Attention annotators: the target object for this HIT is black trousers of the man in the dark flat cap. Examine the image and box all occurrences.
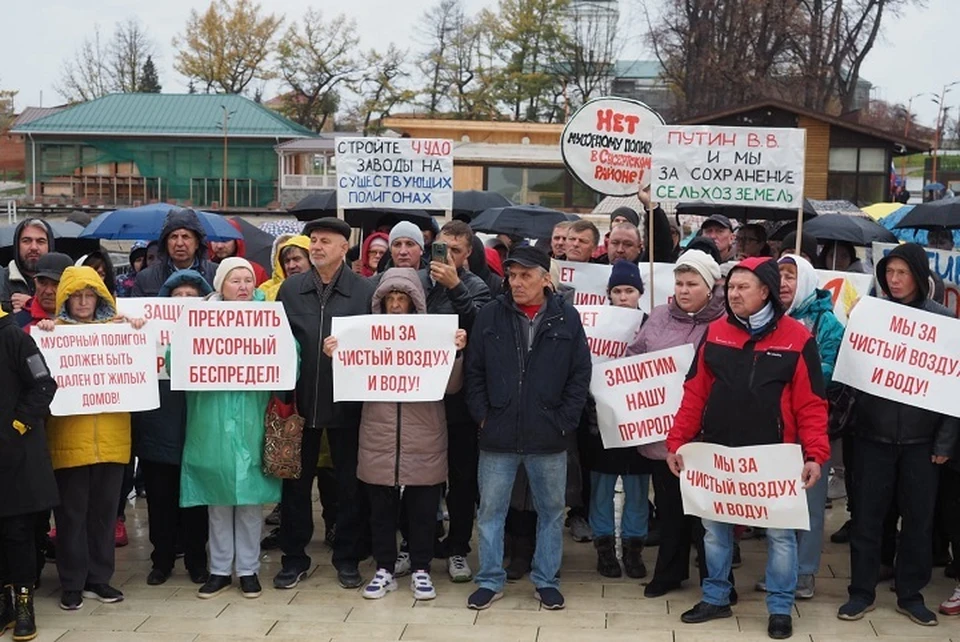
[280,428,370,570]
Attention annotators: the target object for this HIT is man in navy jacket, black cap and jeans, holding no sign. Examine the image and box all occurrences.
[466,247,591,610]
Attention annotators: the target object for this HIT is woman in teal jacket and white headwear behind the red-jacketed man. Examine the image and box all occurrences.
[757,254,843,600]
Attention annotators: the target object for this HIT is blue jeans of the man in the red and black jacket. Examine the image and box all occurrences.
[702,519,797,615]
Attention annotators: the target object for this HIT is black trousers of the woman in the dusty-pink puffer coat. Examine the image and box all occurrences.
[370,484,442,572]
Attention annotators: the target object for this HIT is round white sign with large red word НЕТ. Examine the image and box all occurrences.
[560,98,663,196]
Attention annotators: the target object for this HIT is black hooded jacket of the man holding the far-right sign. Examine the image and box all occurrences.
[854,243,960,457]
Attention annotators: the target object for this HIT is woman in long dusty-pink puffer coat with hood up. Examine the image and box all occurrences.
[323,268,467,600]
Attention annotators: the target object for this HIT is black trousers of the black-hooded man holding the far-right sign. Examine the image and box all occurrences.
[848,438,940,606]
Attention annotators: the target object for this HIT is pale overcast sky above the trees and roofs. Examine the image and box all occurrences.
[0,0,960,125]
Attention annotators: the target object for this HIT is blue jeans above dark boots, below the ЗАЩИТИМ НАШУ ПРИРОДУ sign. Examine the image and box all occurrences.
[590,471,650,538]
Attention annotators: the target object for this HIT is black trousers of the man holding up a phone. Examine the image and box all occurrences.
[444,423,480,555]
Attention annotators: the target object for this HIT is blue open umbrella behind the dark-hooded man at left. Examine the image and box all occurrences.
[80,203,241,241]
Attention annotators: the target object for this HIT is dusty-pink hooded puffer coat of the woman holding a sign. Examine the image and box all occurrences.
[357,268,463,486]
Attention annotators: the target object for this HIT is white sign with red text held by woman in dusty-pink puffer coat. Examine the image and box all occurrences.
[330,314,457,401]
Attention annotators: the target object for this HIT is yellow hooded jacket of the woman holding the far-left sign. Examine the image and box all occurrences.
[47,267,131,470]
